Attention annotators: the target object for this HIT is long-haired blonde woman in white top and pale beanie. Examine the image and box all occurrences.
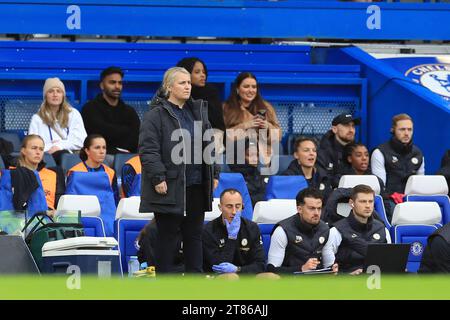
[28,78,87,165]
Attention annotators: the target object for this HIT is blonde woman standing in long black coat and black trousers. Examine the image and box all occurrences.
[139,67,218,273]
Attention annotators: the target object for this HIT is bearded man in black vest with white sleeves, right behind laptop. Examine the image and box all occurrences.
[322,184,391,274]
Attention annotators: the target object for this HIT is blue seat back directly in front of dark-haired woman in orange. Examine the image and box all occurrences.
[66,172,116,237]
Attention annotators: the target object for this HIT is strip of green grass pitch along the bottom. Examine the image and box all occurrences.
[0,275,450,300]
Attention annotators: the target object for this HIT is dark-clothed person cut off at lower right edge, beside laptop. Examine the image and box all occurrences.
[419,223,450,273]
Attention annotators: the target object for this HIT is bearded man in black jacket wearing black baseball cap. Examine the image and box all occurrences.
[317,113,361,187]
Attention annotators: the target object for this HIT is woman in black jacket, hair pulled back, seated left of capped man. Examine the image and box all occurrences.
[283,137,332,203]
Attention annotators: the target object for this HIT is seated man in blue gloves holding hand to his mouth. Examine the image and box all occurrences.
[202,188,265,274]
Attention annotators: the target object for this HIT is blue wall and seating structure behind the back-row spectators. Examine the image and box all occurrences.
[0,41,367,151]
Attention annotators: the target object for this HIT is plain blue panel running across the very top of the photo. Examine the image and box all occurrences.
[0,0,450,40]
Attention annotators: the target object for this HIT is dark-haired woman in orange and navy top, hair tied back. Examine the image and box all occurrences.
[67,134,120,205]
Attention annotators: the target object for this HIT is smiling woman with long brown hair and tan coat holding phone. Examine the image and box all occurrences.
[223,72,281,164]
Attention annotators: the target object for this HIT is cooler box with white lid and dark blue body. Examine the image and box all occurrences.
[42,237,122,276]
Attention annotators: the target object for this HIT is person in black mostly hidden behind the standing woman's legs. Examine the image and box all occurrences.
[136,219,184,272]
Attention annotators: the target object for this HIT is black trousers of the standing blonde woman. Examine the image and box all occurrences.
[155,185,205,273]
